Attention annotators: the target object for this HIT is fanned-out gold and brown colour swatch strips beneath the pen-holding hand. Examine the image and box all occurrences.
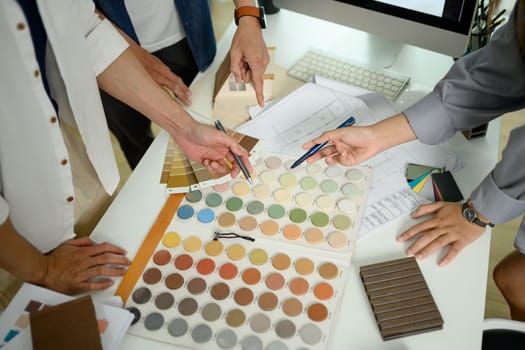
[160,129,259,193]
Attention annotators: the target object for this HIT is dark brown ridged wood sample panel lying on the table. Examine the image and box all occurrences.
[359,257,443,340]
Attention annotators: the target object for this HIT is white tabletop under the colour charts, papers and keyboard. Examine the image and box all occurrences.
[92,10,499,350]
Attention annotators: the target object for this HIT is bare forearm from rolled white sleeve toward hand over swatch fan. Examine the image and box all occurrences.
[97,49,195,135]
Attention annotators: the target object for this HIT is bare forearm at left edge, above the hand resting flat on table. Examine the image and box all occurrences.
[0,219,47,284]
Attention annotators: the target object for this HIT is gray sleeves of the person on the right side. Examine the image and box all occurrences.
[404,9,525,226]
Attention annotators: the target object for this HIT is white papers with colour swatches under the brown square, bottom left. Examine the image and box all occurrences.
[0,283,133,350]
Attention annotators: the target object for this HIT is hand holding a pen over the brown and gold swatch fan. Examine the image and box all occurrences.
[173,123,252,177]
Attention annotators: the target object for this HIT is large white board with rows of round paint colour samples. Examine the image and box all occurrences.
[126,153,372,350]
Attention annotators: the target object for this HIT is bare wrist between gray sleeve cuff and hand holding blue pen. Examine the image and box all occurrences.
[371,113,416,151]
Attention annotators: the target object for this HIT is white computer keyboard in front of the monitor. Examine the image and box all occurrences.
[287,51,410,100]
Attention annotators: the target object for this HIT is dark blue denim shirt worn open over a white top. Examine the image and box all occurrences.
[95,0,217,71]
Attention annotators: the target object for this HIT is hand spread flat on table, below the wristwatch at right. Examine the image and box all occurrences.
[397,202,485,266]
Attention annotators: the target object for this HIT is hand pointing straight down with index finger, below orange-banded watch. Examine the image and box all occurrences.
[230,16,270,107]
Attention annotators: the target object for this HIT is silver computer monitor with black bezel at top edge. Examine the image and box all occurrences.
[274,0,478,61]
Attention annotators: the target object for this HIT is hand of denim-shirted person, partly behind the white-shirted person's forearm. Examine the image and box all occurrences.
[131,45,191,106]
